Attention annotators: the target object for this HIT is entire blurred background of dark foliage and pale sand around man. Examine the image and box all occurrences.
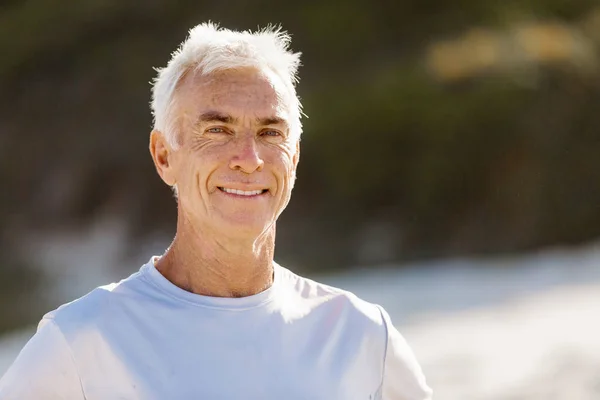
[0,0,600,400]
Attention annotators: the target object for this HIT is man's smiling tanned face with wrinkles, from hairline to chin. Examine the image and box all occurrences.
[152,69,299,236]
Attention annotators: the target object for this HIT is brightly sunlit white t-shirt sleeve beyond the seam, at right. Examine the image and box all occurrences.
[379,307,432,400]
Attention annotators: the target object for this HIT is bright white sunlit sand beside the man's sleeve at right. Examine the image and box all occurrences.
[402,285,600,400]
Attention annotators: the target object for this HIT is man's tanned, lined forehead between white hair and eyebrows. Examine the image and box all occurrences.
[177,68,289,120]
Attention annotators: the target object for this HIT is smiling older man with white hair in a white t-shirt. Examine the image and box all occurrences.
[0,24,431,400]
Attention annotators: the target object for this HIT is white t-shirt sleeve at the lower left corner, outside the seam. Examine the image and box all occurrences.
[0,318,85,400]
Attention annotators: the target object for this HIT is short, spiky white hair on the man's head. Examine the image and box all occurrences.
[151,22,302,147]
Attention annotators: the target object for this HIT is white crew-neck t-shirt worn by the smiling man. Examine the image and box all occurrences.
[0,260,431,400]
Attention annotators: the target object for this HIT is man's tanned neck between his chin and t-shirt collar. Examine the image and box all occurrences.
[156,216,275,297]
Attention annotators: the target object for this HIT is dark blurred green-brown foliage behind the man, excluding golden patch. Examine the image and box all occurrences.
[0,0,600,278]
